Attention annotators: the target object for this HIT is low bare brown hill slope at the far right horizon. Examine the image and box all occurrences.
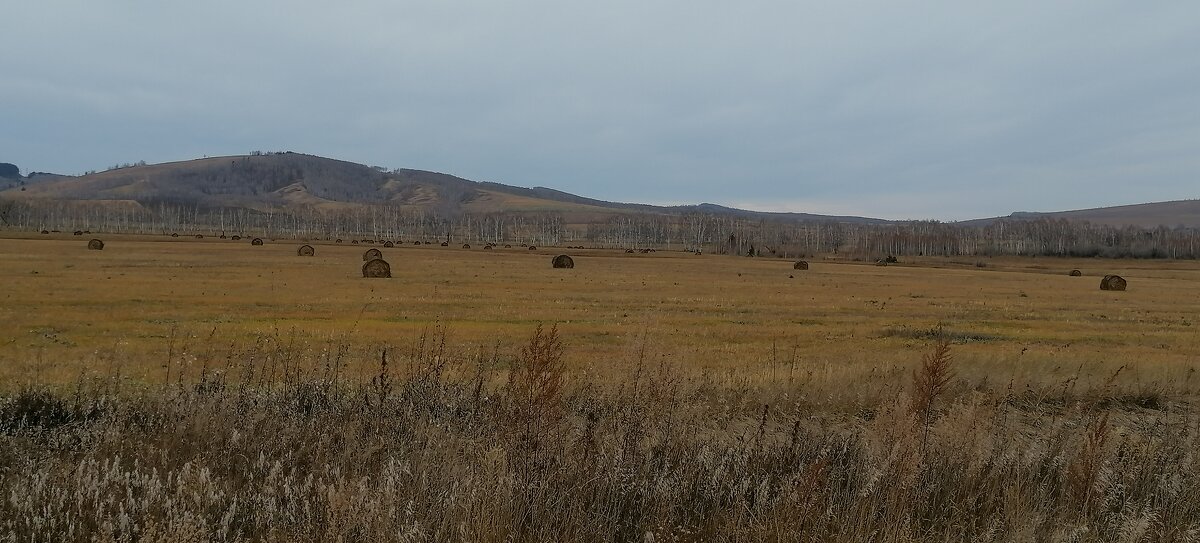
[964,199,1200,228]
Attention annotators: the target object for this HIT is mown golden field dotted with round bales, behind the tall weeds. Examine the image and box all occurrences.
[0,234,1200,391]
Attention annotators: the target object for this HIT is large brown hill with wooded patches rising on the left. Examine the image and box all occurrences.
[0,153,887,223]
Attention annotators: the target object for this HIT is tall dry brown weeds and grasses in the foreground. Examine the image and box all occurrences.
[0,327,1200,542]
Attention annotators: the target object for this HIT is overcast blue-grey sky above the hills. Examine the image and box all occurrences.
[0,0,1200,220]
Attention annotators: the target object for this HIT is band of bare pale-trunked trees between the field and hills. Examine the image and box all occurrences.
[0,199,1200,258]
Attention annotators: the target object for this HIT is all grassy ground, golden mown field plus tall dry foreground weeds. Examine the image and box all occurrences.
[0,234,1200,541]
